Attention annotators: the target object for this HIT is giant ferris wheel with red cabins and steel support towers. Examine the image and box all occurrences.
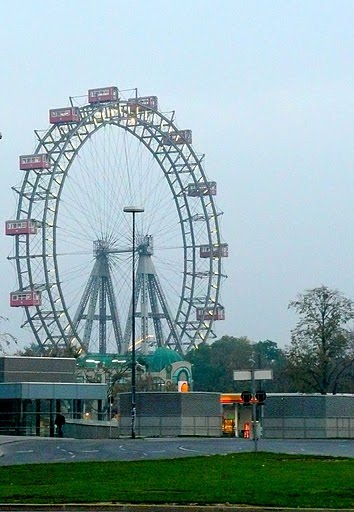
[6,87,228,354]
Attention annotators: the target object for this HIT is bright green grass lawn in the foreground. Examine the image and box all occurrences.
[0,452,354,508]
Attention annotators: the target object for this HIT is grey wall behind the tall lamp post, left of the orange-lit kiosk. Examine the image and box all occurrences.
[119,392,221,437]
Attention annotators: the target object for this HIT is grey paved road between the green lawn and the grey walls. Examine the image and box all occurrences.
[0,436,354,466]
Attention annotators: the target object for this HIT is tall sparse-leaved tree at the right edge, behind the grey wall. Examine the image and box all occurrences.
[286,285,354,394]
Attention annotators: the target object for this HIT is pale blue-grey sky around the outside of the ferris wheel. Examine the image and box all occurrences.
[0,0,354,346]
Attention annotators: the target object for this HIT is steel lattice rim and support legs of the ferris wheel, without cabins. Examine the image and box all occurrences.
[13,90,226,353]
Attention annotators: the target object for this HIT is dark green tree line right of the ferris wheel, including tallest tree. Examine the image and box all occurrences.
[186,286,354,394]
